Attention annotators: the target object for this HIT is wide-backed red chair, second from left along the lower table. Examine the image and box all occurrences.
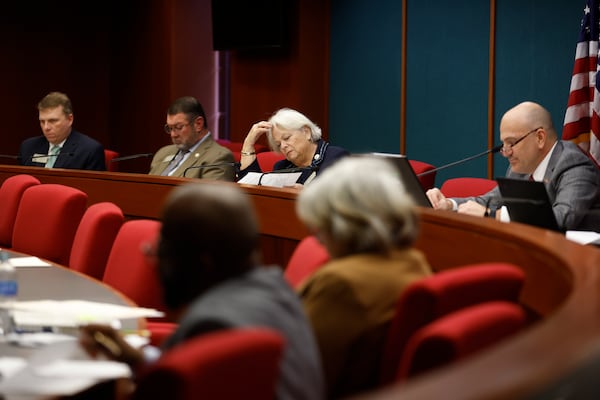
[12,183,88,265]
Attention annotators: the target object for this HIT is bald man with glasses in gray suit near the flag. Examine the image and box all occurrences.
[427,101,600,231]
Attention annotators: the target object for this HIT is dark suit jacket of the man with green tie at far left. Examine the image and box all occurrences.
[19,130,106,171]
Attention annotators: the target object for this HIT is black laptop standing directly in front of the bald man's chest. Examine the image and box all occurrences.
[496,178,561,232]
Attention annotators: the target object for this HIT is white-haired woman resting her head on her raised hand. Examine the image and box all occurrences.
[238,108,349,184]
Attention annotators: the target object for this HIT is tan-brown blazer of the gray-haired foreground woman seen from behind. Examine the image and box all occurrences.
[298,249,432,398]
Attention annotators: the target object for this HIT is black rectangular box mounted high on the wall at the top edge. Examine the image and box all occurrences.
[211,0,294,50]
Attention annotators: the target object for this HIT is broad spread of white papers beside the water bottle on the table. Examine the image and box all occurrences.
[13,300,164,328]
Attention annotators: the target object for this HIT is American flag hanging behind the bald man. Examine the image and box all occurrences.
[562,0,600,163]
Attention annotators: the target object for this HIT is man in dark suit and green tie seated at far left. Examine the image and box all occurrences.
[19,92,106,171]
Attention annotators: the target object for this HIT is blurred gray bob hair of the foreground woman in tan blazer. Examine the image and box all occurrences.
[297,157,417,256]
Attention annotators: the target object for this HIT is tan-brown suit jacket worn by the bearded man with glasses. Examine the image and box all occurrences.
[149,134,236,182]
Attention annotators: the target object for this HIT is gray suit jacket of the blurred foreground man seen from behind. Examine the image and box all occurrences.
[163,267,325,400]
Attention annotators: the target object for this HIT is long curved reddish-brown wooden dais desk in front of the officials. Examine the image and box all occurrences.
[0,166,600,400]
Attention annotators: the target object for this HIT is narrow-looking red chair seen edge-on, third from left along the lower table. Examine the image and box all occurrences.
[69,202,125,280]
